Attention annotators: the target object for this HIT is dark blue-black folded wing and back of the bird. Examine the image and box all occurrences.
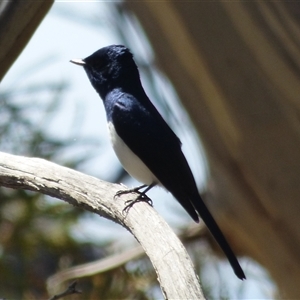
[111,95,199,221]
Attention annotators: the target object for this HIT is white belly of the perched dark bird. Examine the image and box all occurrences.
[108,122,159,185]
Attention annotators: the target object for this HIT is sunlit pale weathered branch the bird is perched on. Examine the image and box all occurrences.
[0,153,204,299]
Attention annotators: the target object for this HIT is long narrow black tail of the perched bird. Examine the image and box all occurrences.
[193,195,246,280]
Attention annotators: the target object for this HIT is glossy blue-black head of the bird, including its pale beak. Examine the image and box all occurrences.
[71,45,139,99]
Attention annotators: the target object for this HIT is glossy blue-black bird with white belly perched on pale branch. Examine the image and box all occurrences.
[70,45,246,280]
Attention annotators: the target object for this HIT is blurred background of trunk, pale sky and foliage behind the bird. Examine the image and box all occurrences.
[0,1,300,299]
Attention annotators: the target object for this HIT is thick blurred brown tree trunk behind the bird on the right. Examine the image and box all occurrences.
[126,1,300,298]
